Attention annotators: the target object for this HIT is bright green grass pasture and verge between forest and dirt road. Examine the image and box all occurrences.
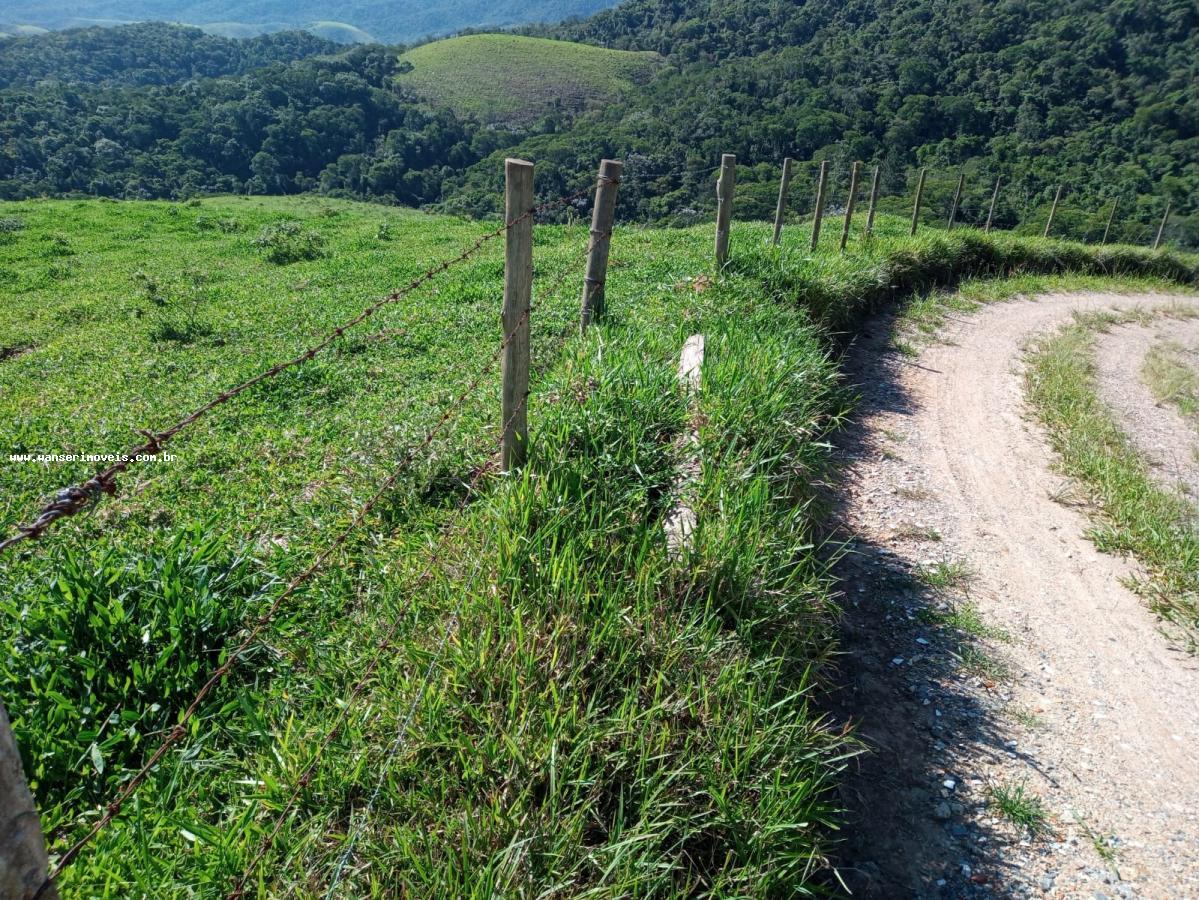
[0,198,1199,896]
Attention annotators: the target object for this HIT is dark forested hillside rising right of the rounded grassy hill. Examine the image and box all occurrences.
[484,0,1199,236]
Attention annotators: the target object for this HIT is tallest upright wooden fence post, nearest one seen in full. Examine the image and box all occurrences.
[500,159,534,472]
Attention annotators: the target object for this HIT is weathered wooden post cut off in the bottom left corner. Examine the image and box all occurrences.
[0,701,59,900]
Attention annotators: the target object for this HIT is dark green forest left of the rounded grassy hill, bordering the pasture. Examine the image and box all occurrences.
[0,47,512,205]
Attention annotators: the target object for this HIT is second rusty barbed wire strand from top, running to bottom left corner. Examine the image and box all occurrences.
[35,210,613,900]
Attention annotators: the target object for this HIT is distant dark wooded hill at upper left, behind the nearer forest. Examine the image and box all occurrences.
[0,22,343,87]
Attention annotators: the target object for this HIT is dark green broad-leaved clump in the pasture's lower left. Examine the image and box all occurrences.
[0,526,259,803]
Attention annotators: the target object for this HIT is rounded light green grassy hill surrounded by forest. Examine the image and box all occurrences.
[399,35,661,125]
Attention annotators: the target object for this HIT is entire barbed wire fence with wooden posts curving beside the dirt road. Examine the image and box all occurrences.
[0,146,1184,898]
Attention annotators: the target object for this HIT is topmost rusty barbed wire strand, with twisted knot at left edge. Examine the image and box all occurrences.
[0,187,591,554]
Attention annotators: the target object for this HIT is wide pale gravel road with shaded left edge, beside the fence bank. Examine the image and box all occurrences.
[832,295,1199,900]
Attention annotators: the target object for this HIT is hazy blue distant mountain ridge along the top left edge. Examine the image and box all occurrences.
[0,0,613,43]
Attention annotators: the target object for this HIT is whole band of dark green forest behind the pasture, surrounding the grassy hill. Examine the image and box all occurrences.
[0,0,1199,246]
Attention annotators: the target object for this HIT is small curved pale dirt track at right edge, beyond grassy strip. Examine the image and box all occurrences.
[1096,319,1199,497]
